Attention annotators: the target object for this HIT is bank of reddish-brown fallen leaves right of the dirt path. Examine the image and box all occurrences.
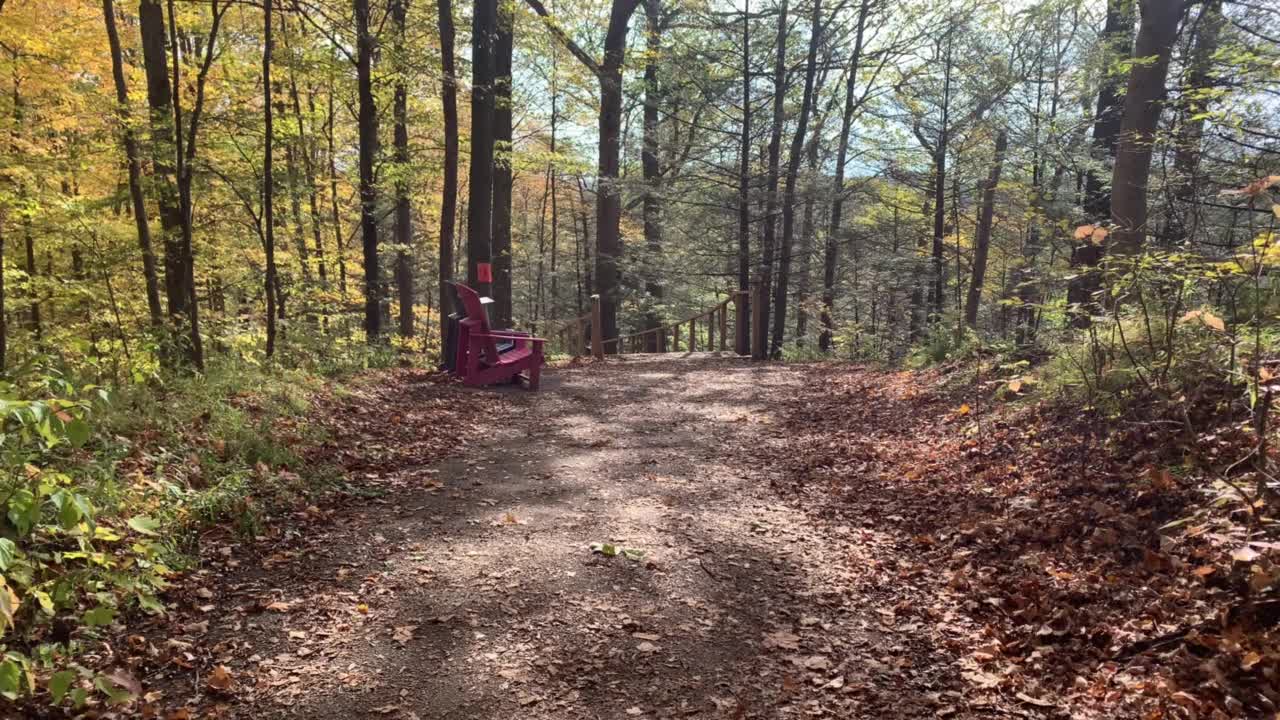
[762,368,1280,719]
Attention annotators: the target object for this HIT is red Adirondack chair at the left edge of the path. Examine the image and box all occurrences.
[453,283,545,389]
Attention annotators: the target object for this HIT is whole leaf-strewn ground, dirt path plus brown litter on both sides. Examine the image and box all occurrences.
[24,355,1277,720]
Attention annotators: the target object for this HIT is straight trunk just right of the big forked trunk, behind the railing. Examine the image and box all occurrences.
[640,0,663,352]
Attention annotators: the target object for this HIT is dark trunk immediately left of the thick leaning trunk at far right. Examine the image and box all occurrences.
[1066,0,1137,327]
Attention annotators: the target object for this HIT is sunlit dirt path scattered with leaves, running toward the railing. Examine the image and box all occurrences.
[164,356,955,719]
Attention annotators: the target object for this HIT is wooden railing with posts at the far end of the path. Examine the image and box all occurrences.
[547,288,759,357]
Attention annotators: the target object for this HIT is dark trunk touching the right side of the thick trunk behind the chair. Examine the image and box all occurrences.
[493,0,516,328]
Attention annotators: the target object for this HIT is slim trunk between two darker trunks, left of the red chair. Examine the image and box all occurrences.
[392,0,413,337]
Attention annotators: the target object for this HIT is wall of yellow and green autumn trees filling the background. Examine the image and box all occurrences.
[0,0,1280,366]
